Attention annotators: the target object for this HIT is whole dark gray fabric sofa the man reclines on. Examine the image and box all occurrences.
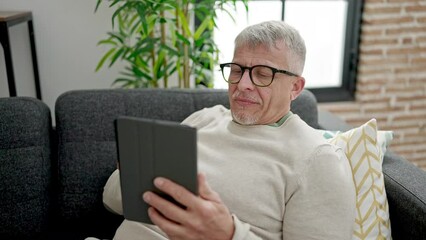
[0,89,426,239]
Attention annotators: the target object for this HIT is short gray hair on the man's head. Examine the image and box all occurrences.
[235,21,306,75]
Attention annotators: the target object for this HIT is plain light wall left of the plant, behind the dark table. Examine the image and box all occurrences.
[0,0,125,119]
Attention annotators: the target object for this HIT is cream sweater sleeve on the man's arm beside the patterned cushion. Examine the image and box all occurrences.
[283,145,356,240]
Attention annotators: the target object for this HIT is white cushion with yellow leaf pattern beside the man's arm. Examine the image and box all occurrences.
[324,119,392,239]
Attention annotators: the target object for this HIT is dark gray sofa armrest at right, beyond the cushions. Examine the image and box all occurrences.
[383,151,426,240]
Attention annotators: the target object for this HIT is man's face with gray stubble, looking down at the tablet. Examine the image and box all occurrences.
[228,43,304,125]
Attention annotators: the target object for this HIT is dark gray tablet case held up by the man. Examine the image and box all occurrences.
[115,117,198,224]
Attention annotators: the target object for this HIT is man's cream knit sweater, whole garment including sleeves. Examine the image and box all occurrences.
[104,106,355,240]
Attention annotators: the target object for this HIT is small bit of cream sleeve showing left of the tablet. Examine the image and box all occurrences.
[102,169,123,215]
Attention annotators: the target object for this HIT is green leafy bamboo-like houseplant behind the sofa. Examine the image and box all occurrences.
[95,0,248,88]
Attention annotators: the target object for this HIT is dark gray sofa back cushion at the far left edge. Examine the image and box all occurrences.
[0,97,52,239]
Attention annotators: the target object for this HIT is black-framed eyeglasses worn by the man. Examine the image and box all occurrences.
[219,63,299,87]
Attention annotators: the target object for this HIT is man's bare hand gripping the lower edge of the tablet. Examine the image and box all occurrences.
[143,174,234,240]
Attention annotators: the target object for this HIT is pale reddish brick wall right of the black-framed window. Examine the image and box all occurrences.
[320,0,426,170]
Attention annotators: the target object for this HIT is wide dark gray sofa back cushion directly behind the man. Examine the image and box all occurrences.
[55,89,318,238]
